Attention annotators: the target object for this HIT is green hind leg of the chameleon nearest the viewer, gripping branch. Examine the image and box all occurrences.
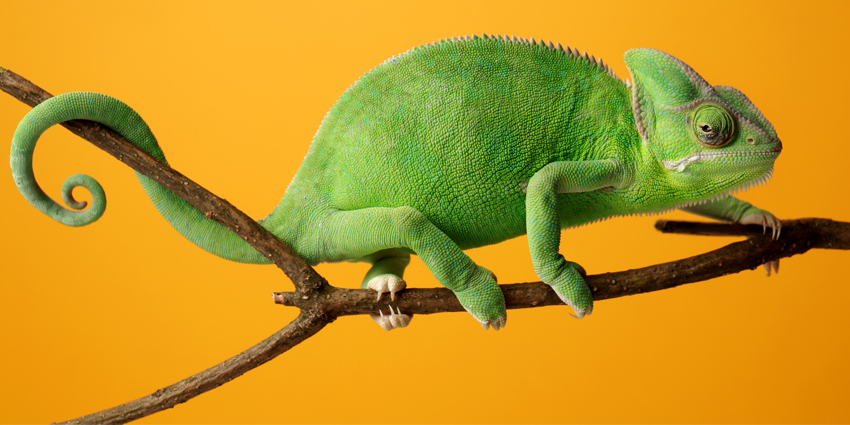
[311,207,506,330]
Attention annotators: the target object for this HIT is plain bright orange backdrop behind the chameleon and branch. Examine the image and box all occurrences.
[0,0,850,423]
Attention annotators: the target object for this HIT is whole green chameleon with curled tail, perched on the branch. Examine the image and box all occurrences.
[11,35,782,330]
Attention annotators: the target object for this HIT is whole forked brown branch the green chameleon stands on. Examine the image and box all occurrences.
[0,68,850,424]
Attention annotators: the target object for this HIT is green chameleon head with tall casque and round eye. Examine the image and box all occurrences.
[625,49,782,201]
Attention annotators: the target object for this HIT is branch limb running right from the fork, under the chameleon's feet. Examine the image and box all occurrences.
[274,218,850,317]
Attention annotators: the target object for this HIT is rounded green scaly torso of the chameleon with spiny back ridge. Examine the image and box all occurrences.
[282,37,638,249]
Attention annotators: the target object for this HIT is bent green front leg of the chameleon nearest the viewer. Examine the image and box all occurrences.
[525,160,622,318]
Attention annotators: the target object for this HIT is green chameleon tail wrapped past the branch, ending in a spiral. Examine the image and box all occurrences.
[11,92,269,264]
